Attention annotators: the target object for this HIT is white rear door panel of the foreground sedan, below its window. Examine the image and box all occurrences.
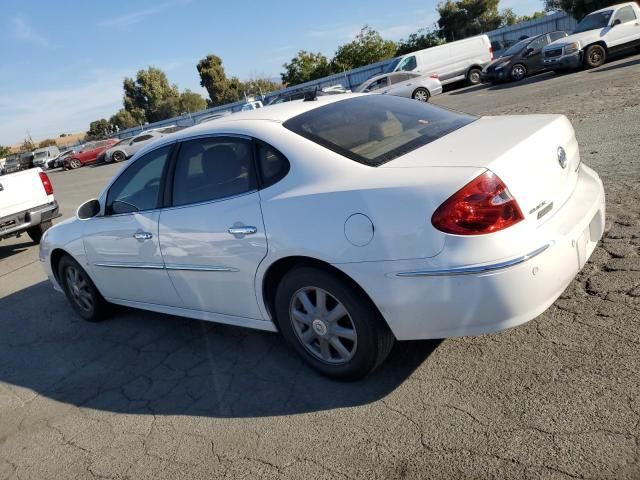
[159,192,267,319]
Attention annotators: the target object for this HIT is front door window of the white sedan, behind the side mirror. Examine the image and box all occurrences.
[105,145,171,215]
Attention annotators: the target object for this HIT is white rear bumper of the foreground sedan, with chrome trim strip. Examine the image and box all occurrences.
[336,166,605,340]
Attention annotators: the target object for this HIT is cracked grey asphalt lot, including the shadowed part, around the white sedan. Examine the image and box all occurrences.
[0,50,640,480]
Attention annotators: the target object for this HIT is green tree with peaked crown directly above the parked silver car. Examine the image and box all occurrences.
[331,25,397,72]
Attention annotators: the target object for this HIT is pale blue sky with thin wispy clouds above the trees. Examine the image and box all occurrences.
[0,0,543,145]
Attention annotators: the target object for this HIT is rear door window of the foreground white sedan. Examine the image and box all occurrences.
[172,137,257,206]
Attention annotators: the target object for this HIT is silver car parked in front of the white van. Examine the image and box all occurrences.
[356,72,442,102]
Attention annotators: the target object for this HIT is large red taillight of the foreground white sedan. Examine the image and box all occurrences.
[431,171,524,235]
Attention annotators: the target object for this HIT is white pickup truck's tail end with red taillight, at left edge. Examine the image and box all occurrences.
[0,168,60,243]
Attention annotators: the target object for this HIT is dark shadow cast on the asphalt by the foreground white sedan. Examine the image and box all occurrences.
[0,282,440,417]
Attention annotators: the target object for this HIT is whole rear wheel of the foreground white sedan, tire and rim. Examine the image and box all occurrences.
[275,267,395,380]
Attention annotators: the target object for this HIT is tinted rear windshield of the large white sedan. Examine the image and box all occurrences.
[284,94,476,167]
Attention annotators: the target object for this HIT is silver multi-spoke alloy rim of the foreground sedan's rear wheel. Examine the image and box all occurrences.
[289,287,358,365]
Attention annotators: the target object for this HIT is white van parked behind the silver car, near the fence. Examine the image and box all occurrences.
[385,35,493,85]
